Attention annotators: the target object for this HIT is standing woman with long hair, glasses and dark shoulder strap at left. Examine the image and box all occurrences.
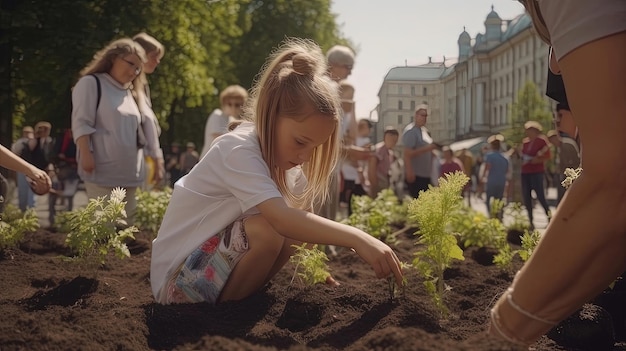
[72,38,147,224]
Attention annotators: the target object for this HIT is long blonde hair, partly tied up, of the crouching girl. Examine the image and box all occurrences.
[244,38,340,209]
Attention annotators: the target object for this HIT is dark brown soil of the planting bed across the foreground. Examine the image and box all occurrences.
[0,230,626,351]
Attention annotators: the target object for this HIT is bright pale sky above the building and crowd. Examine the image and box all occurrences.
[332,0,524,118]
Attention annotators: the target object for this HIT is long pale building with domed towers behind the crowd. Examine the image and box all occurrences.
[376,6,552,148]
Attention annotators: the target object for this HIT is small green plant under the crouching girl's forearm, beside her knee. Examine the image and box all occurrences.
[289,243,330,286]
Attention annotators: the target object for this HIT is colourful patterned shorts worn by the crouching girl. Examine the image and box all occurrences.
[166,218,248,304]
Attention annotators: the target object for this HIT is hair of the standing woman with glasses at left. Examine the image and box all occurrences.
[80,38,148,103]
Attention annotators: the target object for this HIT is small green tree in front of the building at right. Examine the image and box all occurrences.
[503,81,553,145]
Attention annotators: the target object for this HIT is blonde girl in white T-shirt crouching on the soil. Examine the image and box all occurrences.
[150,39,402,304]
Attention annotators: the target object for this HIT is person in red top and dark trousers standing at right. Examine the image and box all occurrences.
[522,121,551,228]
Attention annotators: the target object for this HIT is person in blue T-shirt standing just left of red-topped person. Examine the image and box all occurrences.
[483,134,511,218]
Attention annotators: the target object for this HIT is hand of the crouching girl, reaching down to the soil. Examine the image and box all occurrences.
[354,234,402,286]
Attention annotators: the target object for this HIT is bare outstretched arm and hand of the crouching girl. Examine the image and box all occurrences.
[257,198,402,285]
